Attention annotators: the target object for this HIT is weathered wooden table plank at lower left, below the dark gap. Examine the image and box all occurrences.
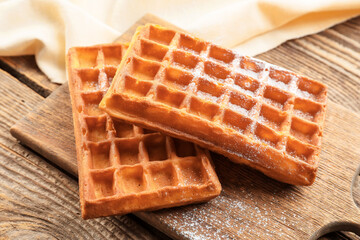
[0,70,163,239]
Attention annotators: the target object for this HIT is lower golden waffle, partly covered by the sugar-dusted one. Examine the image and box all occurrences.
[67,44,221,219]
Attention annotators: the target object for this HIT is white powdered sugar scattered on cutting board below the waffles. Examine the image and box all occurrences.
[155,187,306,240]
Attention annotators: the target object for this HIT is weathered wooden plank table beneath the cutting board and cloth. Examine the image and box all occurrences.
[0,13,360,239]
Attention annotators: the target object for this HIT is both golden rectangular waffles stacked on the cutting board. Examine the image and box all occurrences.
[67,24,327,218]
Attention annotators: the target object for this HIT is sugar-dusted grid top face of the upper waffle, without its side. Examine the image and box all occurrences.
[102,25,326,186]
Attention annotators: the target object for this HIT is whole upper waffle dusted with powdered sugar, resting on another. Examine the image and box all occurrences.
[100,25,327,185]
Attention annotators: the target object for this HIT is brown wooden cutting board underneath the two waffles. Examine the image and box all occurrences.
[11,15,360,239]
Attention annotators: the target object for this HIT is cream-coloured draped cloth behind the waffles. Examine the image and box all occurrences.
[0,0,360,83]
